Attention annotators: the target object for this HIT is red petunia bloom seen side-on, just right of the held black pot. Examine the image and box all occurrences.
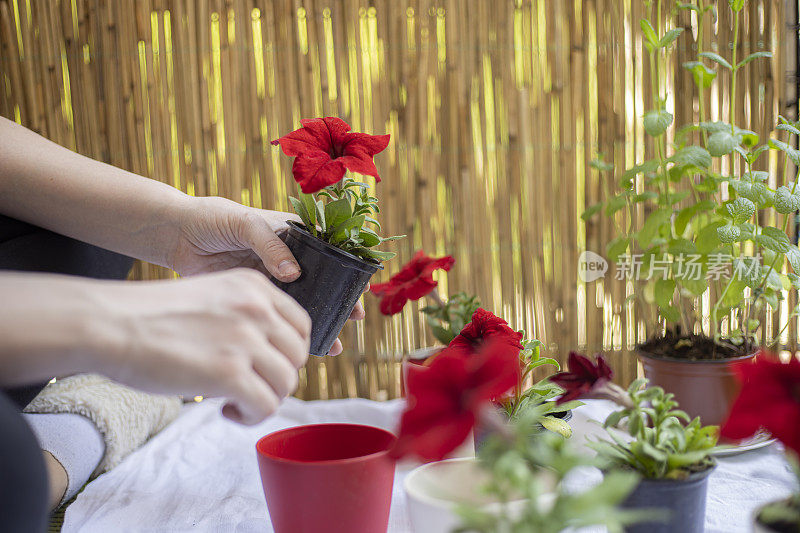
[370,250,456,315]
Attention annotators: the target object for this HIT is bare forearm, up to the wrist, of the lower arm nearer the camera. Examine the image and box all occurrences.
[0,273,119,386]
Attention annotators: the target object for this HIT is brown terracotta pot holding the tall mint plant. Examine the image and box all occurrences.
[637,350,756,426]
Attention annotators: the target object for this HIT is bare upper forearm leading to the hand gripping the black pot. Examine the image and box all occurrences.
[0,117,190,266]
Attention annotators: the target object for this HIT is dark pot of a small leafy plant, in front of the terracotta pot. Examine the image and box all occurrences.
[622,465,716,533]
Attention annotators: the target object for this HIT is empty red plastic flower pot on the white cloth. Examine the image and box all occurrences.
[256,424,397,533]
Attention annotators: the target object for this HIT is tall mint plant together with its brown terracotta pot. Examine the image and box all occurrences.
[583,0,800,424]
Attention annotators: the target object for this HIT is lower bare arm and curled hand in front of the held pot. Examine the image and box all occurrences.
[0,269,311,424]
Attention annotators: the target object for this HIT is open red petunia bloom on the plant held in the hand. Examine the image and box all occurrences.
[272,117,389,194]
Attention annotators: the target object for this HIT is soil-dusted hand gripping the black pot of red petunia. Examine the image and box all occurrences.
[172,197,364,355]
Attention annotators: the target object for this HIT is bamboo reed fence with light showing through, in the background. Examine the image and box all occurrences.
[0,0,797,399]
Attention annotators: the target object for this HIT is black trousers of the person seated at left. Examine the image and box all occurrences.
[0,215,133,533]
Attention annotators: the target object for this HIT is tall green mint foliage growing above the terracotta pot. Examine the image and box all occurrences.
[582,0,800,339]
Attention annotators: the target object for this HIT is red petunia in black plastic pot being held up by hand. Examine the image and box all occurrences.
[272,117,403,356]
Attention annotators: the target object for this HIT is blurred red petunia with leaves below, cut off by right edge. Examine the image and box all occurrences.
[720,354,800,533]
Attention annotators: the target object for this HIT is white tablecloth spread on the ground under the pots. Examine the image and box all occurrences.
[63,399,795,533]
